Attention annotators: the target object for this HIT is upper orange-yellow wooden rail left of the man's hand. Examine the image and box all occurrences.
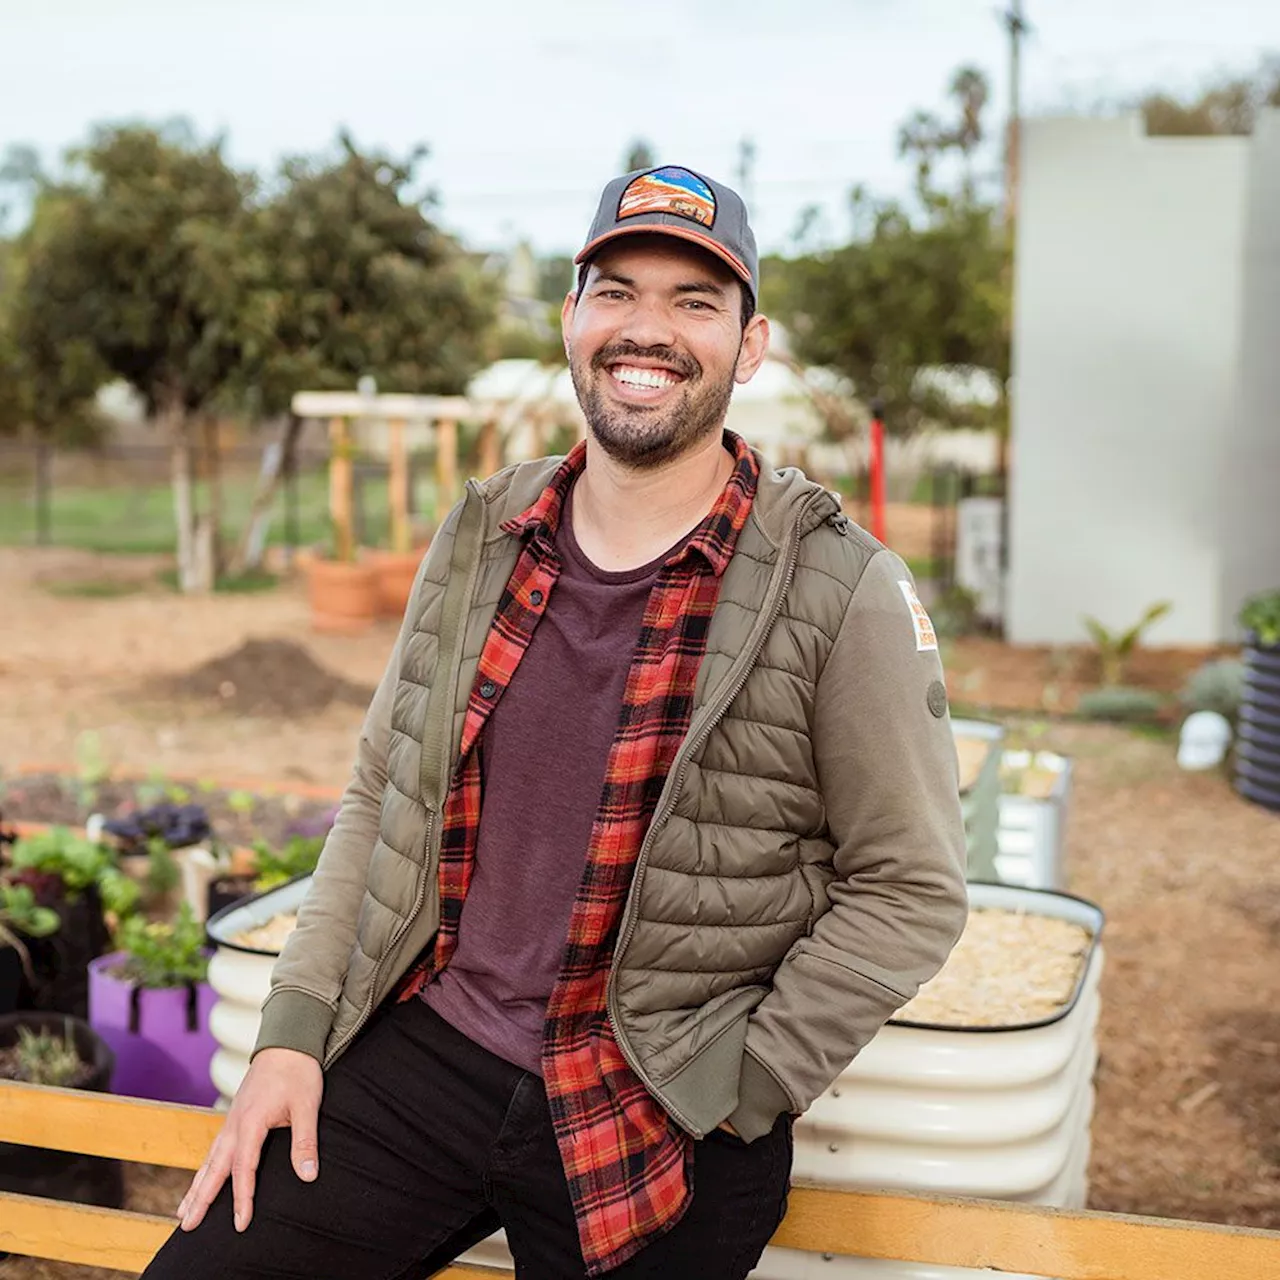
[0,1080,223,1169]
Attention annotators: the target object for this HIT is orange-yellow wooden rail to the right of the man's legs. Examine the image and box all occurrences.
[773,1187,1280,1280]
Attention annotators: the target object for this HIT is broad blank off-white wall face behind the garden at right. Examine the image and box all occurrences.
[1006,118,1249,644]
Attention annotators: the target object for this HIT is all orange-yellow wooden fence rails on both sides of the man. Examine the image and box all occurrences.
[0,1083,1280,1280]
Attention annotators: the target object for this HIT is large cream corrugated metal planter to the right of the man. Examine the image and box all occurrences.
[754,884,1102,1280]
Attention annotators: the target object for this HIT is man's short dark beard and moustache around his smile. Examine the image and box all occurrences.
[568,343,733,471]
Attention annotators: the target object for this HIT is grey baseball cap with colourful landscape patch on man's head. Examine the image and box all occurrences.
[573,165,760,303]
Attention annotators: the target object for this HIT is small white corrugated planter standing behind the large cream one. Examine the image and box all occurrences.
[996,751,1071,888]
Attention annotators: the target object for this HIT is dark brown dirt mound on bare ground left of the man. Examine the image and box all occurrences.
[164,639,374,716]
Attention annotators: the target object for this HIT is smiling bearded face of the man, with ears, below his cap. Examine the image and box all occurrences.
[562,234,769,470]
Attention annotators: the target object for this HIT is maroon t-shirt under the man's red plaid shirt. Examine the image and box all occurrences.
[422,493,686,1075]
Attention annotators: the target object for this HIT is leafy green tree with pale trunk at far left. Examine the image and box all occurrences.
[10,125,258,590]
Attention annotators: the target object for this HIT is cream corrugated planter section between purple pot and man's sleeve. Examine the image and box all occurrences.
[206,876,311,1106]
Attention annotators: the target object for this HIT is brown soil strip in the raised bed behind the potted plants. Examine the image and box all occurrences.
[4,773,334,845]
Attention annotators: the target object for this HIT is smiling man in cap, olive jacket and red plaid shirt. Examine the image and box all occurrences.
[147,166,965,1280]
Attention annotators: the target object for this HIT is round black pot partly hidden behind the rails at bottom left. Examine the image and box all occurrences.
[0,1012,124,1208]
